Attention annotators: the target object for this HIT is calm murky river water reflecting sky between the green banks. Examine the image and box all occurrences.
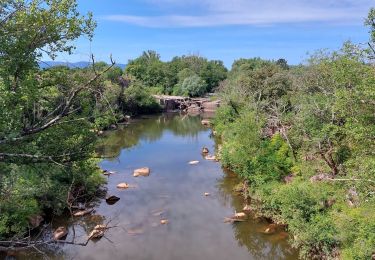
[9,114,298,260]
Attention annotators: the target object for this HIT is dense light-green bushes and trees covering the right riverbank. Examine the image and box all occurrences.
[214,13,375,259]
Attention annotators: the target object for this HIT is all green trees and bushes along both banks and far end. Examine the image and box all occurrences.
[0,0,375,259]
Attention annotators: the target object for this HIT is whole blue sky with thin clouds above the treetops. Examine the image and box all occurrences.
[58,0,375,67]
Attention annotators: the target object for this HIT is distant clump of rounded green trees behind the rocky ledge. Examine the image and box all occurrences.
[125,51,227,97]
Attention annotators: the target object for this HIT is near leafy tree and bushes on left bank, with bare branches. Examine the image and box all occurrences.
[0,0,113,239]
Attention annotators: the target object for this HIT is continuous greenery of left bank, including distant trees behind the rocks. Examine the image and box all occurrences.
[0,0,227,244]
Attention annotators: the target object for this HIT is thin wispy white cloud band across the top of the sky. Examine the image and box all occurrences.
[104,0,375,27]
